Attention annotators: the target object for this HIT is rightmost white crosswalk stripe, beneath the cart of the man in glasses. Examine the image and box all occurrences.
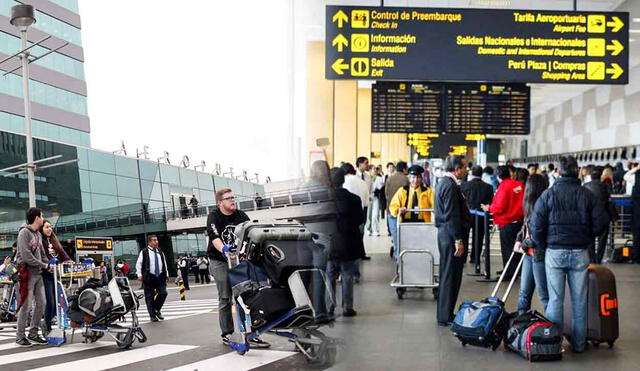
[165,350,296,371]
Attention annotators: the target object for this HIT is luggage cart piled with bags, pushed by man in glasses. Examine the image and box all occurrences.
[227,220,340,366]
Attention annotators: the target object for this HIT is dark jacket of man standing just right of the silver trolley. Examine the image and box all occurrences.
[436,176,471,240]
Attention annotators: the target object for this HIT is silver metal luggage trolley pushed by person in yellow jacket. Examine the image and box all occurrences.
[391,209,440,300]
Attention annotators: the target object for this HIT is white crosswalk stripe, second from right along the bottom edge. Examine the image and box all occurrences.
[27,344,197,371]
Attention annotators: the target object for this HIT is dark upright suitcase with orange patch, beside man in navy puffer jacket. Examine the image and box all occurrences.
[563,265,619,347]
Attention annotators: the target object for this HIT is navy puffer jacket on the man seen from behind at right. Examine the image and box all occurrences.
[529,178,609,249]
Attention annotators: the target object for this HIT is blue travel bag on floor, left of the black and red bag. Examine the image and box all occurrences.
[451,297,506,350]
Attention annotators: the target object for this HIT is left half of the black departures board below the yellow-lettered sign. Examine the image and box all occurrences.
[371,82,443,133]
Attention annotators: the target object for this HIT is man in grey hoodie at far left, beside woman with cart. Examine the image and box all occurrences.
[16,207,55,347]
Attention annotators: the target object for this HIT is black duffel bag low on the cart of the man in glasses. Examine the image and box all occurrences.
[245,287,296,329]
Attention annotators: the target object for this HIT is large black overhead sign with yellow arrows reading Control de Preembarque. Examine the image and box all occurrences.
[325,6,629,84]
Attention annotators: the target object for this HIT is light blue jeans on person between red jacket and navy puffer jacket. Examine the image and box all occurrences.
[518,254,549,311]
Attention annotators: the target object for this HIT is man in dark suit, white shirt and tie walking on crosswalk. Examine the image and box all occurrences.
[136,234,168,322]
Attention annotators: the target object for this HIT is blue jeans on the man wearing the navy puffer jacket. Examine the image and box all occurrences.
[545,249,589,352]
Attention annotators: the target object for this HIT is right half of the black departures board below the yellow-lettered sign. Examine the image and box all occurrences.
[445,84,531,135]
